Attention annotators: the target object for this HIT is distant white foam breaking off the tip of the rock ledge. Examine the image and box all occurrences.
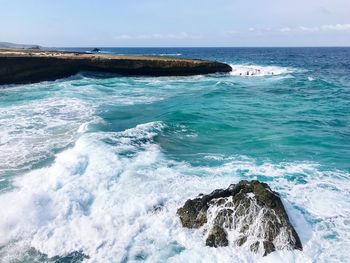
[230,64,292,77]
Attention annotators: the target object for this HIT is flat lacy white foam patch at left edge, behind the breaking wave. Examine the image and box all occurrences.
[0,98,93,170]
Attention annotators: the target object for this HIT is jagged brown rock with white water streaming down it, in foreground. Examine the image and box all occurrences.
[177,180,302,255]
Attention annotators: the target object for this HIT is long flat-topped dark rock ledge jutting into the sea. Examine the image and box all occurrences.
[0,49,232,85]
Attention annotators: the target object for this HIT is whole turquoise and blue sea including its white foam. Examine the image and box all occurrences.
[0,48,350,262]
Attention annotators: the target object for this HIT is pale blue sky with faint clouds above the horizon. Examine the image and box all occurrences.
[0,0,350,47]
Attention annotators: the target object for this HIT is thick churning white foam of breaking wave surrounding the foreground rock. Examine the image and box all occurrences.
[0,122,350,262]
